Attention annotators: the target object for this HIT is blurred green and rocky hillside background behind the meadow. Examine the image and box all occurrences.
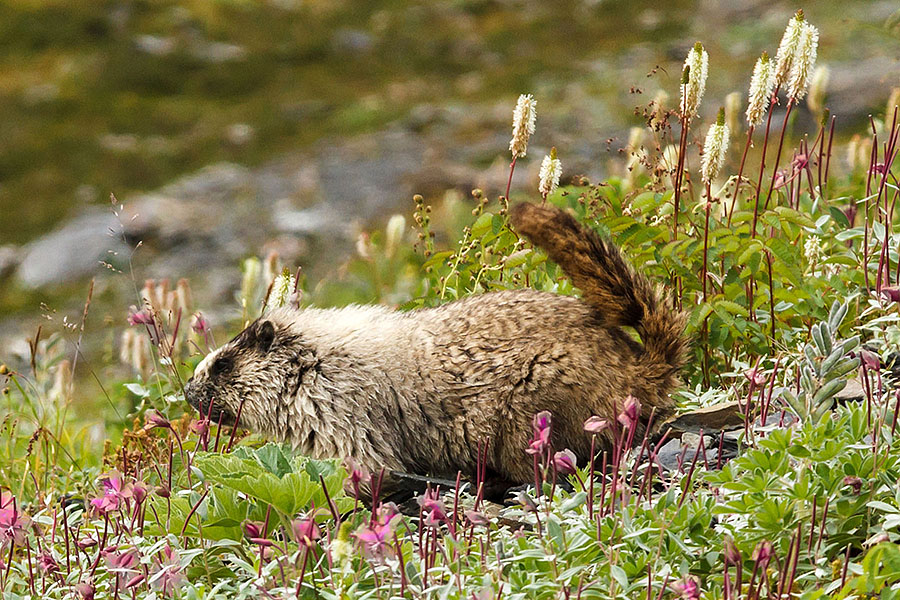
[0,0,900,372]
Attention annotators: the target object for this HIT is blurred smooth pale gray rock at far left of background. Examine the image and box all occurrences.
[16,213,128,289]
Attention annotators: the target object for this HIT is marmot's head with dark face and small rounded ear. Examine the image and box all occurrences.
[184,316,316,432]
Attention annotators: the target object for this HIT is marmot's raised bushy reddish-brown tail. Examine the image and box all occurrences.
[510,203,686,374]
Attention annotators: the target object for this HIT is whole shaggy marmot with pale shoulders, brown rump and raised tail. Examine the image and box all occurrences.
[185,204,686,483]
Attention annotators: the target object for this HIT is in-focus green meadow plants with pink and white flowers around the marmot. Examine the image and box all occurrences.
[0,11,900,600]
